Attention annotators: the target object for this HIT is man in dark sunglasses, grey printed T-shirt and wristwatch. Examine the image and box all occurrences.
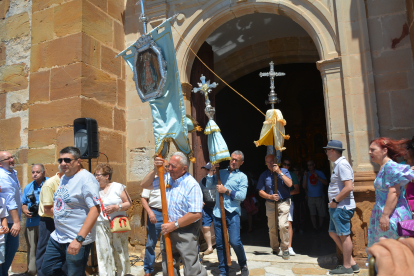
[42,147,100,276]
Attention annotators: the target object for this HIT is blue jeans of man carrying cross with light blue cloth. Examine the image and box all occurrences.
[214,210,247,275]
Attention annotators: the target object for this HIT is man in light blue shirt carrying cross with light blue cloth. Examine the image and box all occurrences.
[207,150,249,276]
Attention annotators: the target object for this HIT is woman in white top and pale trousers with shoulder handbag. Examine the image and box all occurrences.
[95,164,131,276]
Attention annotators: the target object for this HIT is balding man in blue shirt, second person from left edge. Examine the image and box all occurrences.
[22,164,48,275]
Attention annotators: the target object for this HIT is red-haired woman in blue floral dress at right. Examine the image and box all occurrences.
[367,137,414,247]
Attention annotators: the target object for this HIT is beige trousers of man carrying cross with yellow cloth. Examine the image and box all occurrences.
[266,199,290,252]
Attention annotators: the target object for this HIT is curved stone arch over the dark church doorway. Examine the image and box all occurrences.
[176,0,339,83]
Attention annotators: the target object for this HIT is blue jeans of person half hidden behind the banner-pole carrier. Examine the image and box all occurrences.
[144,209,163,273]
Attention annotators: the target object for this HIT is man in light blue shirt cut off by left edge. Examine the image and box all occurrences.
[0,151,22,276]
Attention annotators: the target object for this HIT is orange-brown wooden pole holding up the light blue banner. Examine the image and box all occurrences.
[157,154,174,276]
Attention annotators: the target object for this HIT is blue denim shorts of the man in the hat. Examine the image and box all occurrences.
[329,208,355,236]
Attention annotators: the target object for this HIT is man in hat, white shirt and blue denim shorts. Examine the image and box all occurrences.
[324,140,359,275]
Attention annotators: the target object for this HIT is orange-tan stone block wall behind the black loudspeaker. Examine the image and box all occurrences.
[0,0,127,271]
